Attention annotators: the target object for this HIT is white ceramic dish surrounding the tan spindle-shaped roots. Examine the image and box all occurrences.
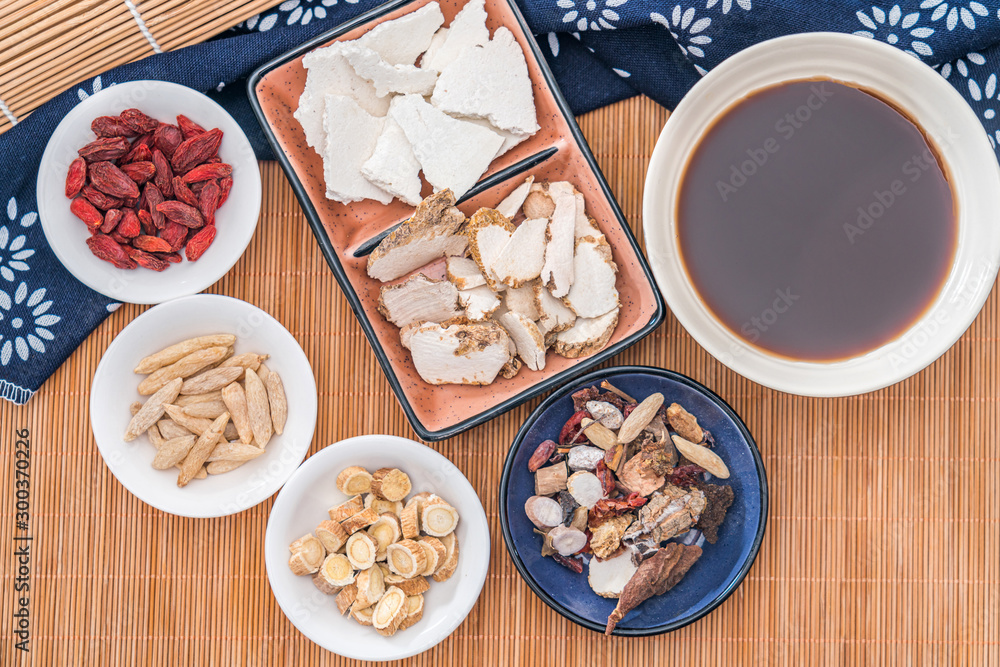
[90,294,316,517]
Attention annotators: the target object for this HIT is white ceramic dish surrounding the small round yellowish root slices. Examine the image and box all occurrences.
[264,435,490,661]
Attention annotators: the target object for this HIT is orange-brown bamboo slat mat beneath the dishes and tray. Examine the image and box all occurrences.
[0,1,1000,667]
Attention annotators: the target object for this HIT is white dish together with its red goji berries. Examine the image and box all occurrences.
[37,81,261,304]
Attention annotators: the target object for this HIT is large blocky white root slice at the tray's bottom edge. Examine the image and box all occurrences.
[400,322,510,385]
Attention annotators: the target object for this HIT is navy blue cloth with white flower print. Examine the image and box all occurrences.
[0,0,1000,403]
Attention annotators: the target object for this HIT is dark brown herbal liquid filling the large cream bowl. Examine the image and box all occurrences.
[677,81,957,361]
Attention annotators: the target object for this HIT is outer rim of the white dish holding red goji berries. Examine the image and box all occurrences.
[35,79,263,305]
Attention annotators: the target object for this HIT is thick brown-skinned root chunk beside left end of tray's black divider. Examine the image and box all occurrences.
[368,189,467,282]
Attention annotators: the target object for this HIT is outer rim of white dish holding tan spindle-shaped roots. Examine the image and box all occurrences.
[88,293,319,519]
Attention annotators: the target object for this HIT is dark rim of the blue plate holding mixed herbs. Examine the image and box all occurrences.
[499,366,770,637]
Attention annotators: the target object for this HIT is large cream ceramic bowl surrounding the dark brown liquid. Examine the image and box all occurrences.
[643,33,1000,396]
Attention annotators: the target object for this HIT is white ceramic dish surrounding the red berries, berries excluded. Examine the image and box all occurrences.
[37,81,261,303]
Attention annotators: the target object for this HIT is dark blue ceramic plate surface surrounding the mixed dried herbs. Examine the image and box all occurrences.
[500,366,768,636]
